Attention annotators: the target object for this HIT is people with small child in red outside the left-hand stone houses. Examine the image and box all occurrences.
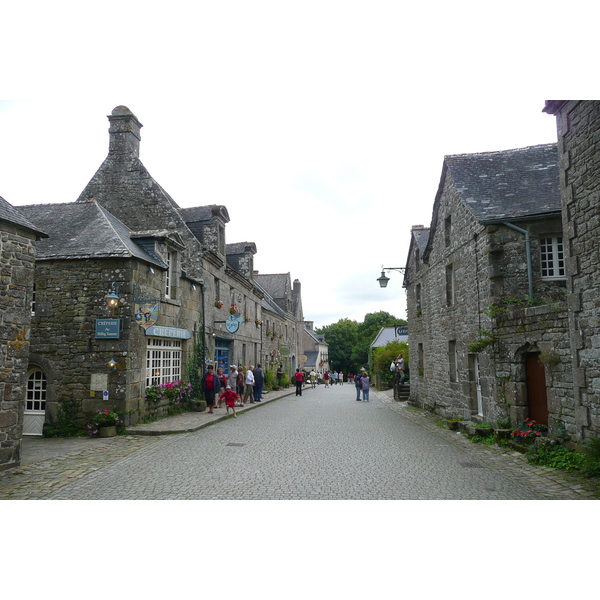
[201,364,265,417]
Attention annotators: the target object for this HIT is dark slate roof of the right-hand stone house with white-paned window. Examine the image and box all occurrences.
[444,144,561,223]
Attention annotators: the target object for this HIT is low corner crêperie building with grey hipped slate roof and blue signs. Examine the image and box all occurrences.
[19,200,202,428]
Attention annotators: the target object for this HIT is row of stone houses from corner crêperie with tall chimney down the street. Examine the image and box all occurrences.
[14,106,310,432]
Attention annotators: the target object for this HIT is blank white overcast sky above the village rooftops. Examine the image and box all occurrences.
[0,0,595,327]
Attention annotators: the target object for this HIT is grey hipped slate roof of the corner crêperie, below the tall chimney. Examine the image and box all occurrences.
[18,201,166,268]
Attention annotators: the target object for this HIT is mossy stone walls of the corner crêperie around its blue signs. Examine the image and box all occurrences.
[30,259,202,424]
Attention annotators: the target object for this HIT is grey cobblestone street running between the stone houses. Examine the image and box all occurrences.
[0,385,598,500]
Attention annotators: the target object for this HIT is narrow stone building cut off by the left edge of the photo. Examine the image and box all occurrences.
[0,197,46,471]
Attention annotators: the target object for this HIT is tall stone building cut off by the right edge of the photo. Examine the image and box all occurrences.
[544,100,600,439]
